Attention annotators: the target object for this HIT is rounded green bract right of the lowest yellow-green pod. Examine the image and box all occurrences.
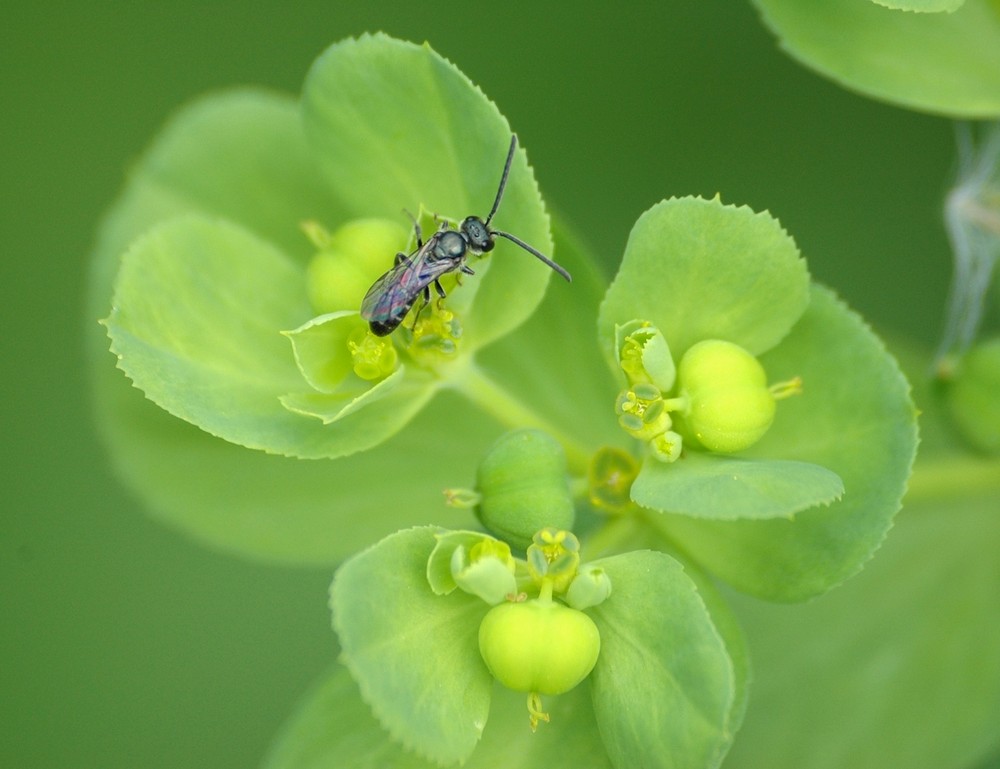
[590,551,735,769]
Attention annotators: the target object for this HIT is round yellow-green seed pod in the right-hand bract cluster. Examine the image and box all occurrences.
[678,339,775,452]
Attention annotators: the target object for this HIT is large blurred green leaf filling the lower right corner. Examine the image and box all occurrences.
[726,472,1000,769]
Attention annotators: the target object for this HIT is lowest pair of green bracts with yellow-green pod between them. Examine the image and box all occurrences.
[328,527,746,769]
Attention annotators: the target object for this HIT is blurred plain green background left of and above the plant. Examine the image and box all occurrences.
[0,0,954,769]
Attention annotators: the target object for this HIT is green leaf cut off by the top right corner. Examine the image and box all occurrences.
[755,0,1000,118]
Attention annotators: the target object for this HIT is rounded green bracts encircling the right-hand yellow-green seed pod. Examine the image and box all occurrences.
[592,198,916,600]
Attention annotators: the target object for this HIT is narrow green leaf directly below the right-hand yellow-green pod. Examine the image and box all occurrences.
[632,451,844,520]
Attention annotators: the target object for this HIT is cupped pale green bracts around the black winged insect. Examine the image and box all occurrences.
[98,36,552,457]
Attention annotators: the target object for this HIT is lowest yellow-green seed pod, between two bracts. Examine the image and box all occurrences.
[479,598,601,694]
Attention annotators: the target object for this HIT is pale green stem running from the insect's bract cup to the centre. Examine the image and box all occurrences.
[449,362,590,475]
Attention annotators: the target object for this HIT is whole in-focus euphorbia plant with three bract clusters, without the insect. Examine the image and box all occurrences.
[94,30,916,767]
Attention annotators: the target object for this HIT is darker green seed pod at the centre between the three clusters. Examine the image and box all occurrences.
[476,430,575,550]
